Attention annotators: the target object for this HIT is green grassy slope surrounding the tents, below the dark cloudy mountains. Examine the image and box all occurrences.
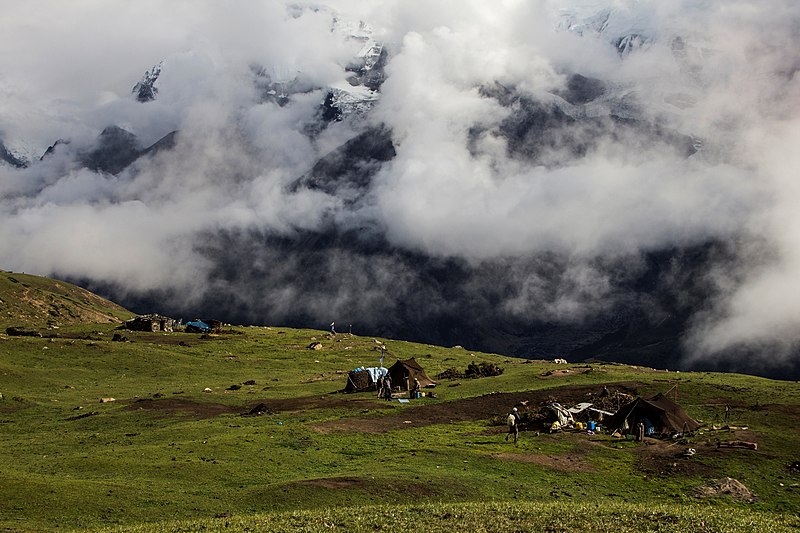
[0,276,800,531]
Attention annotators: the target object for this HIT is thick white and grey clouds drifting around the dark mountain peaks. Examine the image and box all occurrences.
[0,0,800,368]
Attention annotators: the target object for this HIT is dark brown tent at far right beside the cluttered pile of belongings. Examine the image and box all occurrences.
[605,393,700,435]
